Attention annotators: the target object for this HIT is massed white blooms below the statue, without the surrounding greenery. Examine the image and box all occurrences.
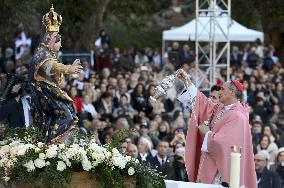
[0,137,139,182]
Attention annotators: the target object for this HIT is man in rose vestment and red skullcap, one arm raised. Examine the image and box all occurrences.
[177,70,257,188]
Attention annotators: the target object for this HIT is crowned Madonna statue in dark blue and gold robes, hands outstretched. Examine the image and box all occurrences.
[29,6,82,143]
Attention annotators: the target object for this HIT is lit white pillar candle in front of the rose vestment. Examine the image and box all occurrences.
[230,145,241,188]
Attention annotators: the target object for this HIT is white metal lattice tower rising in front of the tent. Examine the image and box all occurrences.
[194,0,231,91]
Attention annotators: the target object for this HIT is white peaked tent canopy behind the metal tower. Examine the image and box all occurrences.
[163,15,264,42]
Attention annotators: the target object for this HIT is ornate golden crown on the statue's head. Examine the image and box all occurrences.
[42,5,62,32]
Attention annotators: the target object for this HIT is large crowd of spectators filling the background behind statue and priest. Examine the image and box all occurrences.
[0,30,284,188]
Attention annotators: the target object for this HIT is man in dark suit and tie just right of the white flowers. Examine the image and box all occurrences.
[150,140,174,180]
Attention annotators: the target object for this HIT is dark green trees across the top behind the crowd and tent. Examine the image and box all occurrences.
[0,0,284,59]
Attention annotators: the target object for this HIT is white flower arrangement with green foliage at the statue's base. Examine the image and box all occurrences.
[0,128,165,188]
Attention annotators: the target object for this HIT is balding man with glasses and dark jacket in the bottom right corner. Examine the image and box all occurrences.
[254,150,281,188]
